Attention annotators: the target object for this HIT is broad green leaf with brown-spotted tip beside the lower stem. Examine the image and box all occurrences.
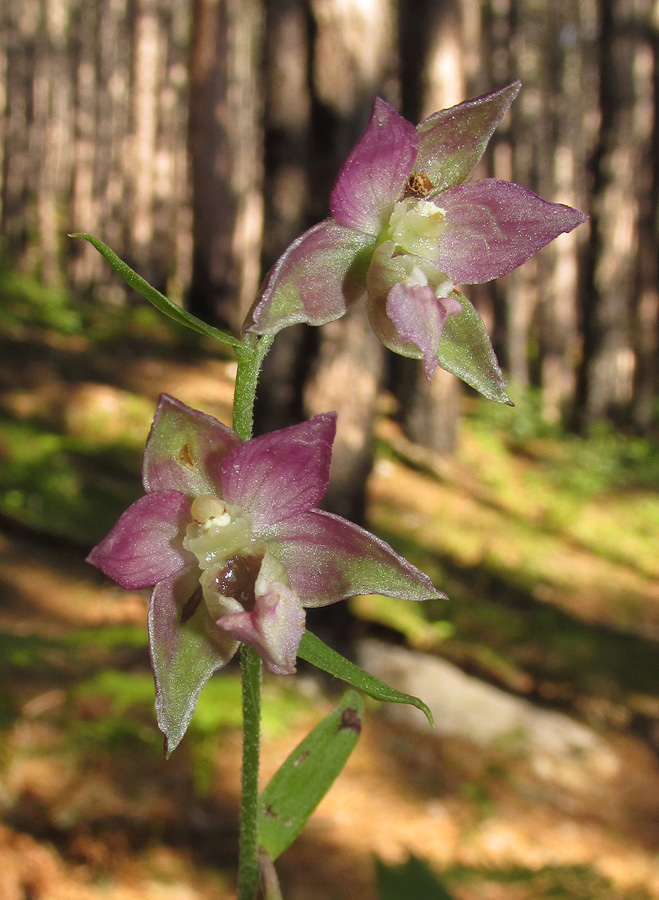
[258,690,364,860]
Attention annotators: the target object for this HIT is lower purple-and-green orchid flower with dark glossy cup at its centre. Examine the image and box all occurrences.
[88,394,443,750]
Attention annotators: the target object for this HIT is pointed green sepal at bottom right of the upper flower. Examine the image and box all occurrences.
[437,291,513,406]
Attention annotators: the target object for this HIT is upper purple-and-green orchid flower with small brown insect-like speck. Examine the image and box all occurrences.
[245,82,587,401]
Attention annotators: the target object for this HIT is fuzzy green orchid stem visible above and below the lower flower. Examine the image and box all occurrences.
[233,335,274,900]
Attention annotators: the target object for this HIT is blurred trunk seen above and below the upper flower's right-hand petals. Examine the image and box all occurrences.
[391,0,466,454]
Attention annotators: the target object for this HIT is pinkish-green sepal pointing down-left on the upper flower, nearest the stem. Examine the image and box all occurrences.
[243,219,375,334]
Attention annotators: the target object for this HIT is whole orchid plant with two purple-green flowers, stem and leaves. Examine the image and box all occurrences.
[72,82,587,900]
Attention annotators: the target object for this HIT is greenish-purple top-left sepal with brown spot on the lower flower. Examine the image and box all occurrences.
[142,394,241,496]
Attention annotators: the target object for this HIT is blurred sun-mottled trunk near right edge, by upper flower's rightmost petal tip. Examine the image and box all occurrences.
[576,0,639,430]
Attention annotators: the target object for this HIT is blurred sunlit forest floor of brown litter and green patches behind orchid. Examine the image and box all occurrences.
[0,276,659,900]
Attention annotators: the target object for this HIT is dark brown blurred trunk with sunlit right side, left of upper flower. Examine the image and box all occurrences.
[189,0,263,330]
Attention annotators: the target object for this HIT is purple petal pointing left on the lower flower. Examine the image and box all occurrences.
[87,491,190,590]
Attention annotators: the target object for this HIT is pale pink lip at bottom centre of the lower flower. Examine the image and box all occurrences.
[217,584,305,675]
